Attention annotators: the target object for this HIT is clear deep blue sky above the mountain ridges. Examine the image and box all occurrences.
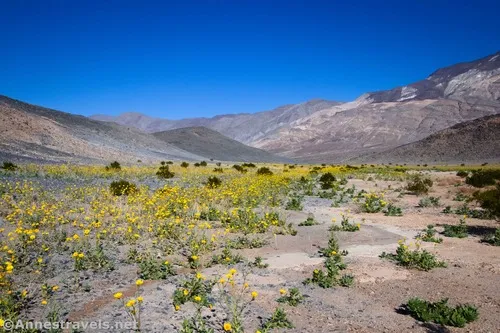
[0,0,500,119]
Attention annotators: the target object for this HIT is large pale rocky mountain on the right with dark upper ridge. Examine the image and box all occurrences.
[251,53,500,162]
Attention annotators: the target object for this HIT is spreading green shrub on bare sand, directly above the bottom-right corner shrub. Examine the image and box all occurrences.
[380,242,446,271]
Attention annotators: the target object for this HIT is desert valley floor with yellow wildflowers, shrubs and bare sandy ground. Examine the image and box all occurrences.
[0,162,500,333]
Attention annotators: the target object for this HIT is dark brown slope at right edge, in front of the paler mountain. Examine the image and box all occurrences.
[351,115,500,163]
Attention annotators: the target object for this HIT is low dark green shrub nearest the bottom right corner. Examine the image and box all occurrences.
[404,298,479,327]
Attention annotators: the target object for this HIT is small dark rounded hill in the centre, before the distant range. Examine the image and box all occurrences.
[153,127,290,162]
